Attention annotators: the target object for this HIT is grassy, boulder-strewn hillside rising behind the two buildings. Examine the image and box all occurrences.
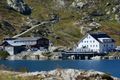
[0,0,120,47]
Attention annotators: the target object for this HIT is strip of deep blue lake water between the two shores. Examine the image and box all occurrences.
[0,60,120,78]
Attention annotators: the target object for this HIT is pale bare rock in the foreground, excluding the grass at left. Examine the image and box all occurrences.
[17,69,118,80]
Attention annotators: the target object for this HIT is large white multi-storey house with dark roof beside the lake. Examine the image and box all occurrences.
[74,32,116,53]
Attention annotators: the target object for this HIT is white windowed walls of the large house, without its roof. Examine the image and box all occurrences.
[76,34,116,53]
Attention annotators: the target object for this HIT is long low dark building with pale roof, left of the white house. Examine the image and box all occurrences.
[2,37,49,55]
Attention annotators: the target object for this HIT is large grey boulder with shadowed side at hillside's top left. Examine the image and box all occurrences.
[7,0,31,15]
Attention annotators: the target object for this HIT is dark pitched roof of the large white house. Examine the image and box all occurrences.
[89,32,115,42]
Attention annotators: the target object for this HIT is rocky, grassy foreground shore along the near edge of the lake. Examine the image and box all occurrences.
[0,69,119,80]
